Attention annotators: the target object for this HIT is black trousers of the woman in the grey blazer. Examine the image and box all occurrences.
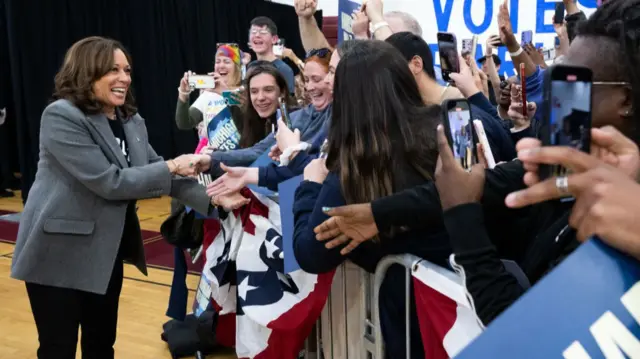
[27,259,123,359]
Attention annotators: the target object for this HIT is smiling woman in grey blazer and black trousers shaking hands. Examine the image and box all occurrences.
[11,37,221,359]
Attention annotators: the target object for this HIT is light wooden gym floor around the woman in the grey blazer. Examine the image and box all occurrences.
[0,192,236,359]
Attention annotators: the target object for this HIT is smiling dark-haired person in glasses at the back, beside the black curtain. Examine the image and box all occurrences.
[249,16,296,94]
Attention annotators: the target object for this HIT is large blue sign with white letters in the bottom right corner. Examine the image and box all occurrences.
[456,239,640,359]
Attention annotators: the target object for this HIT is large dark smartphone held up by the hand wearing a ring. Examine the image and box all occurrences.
[539,65,593,180]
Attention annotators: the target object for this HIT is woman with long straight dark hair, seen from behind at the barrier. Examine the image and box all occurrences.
[294,41,451,357]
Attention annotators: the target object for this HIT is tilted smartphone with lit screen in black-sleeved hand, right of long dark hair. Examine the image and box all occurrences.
[442,99,478,170]
